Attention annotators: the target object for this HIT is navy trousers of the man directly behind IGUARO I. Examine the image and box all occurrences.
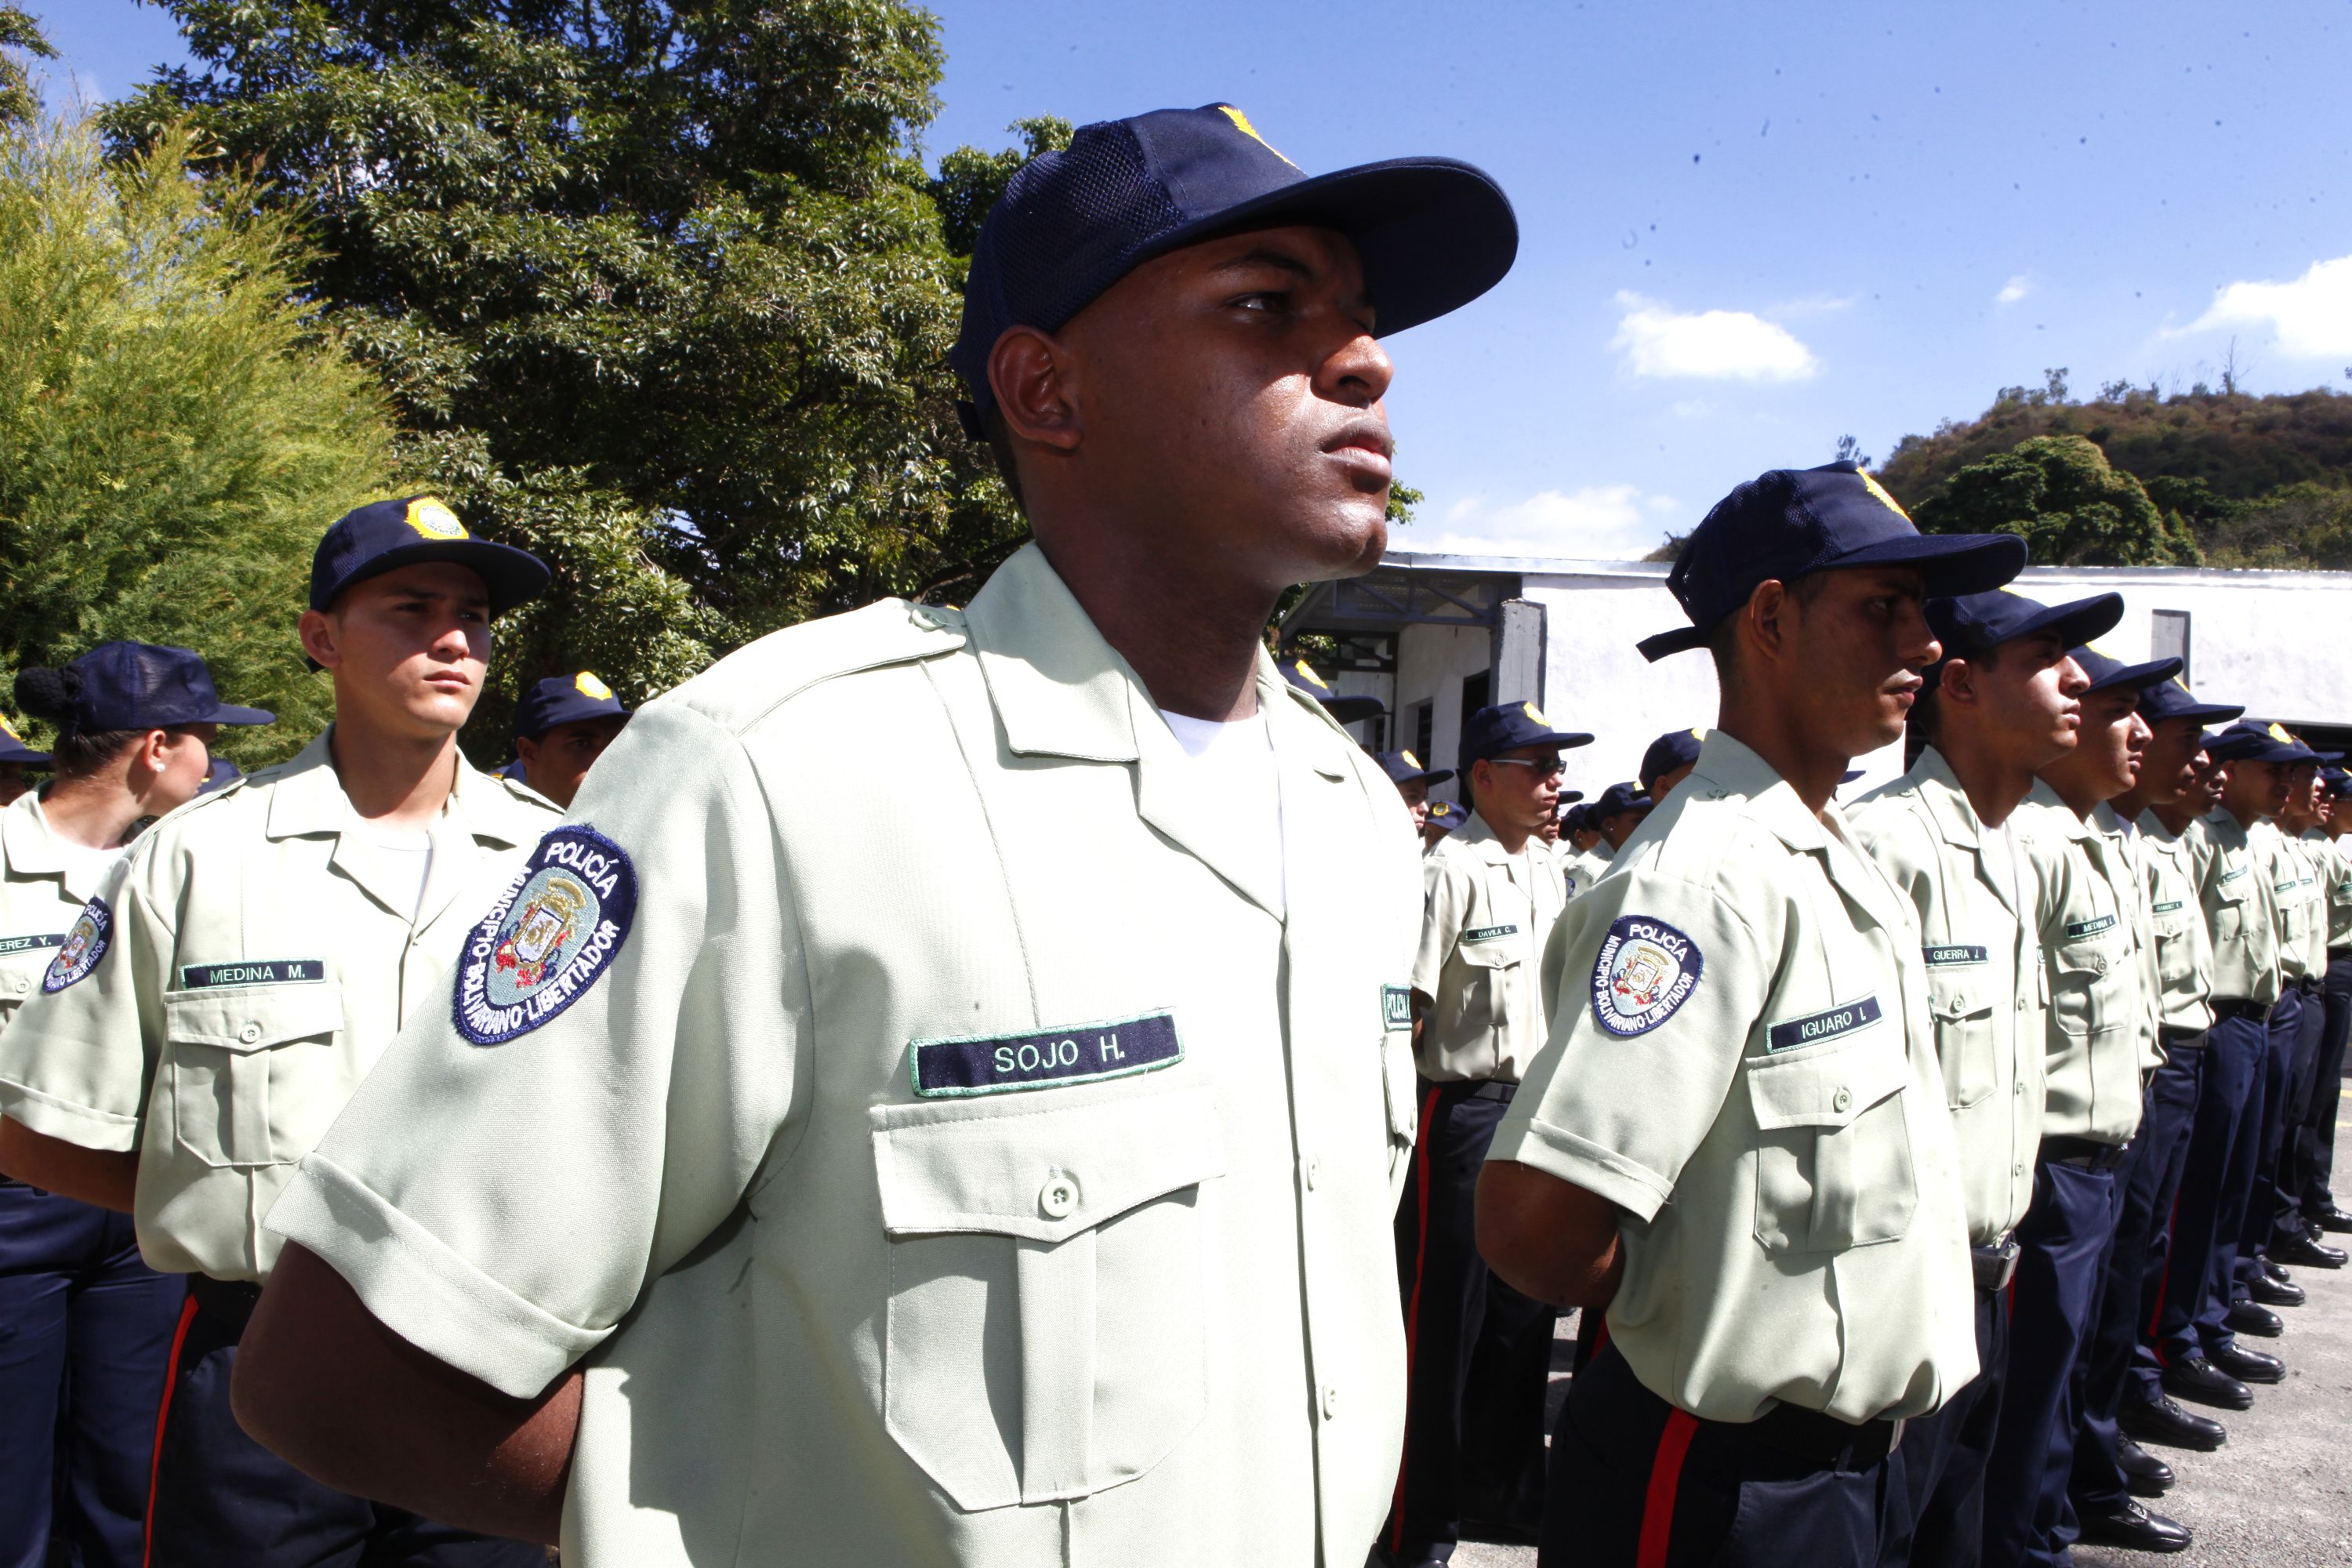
[1879,1290,2009,1568]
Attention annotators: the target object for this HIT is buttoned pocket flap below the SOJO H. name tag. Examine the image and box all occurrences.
[873,1088,1225,1241]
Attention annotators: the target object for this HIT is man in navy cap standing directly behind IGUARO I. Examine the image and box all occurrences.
[1851,588,2124,1566]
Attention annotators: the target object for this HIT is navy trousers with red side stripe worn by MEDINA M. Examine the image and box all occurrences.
[148,1286,548,1568]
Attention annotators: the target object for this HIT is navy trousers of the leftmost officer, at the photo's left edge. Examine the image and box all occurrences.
[0,1180,186,1568]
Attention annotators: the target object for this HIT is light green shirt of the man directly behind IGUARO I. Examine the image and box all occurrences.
[1851,748,2044,1246]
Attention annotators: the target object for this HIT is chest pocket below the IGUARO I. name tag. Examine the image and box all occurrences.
[1748,1020,1919,1253]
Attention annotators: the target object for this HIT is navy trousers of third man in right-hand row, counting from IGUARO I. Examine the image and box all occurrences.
[1983,1156,2114,1568]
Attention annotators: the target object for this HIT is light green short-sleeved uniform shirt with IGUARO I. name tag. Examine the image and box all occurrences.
[1489,731,1976,1422]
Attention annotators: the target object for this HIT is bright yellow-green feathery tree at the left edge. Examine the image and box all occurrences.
[0,122,393,764]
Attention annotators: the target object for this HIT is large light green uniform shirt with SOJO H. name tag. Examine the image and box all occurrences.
[270,546,1418,1568]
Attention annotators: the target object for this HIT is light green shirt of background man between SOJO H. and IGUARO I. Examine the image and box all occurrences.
[1414,813,1566,1083]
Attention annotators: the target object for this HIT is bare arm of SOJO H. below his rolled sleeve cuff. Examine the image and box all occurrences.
[230,1246,581,1544]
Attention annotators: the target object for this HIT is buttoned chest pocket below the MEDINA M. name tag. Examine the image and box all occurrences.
[162,980,355,1166]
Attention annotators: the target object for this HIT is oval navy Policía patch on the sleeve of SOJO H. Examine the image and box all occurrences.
[449,822,637,1046]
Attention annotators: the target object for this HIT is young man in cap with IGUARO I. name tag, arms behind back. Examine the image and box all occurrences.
[1479,463,2025,1566]
